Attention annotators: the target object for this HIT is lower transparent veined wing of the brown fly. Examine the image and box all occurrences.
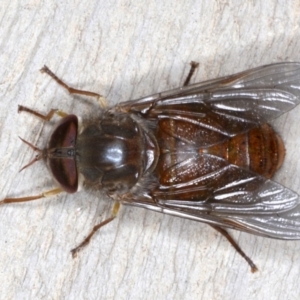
[123,154,300,239]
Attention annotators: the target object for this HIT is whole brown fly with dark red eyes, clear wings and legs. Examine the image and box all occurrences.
[2,63,300,271]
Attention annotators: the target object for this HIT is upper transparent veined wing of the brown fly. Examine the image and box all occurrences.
[116,63,300,136]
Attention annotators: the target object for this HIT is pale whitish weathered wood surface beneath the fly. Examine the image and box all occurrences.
[0,0,300,300]
